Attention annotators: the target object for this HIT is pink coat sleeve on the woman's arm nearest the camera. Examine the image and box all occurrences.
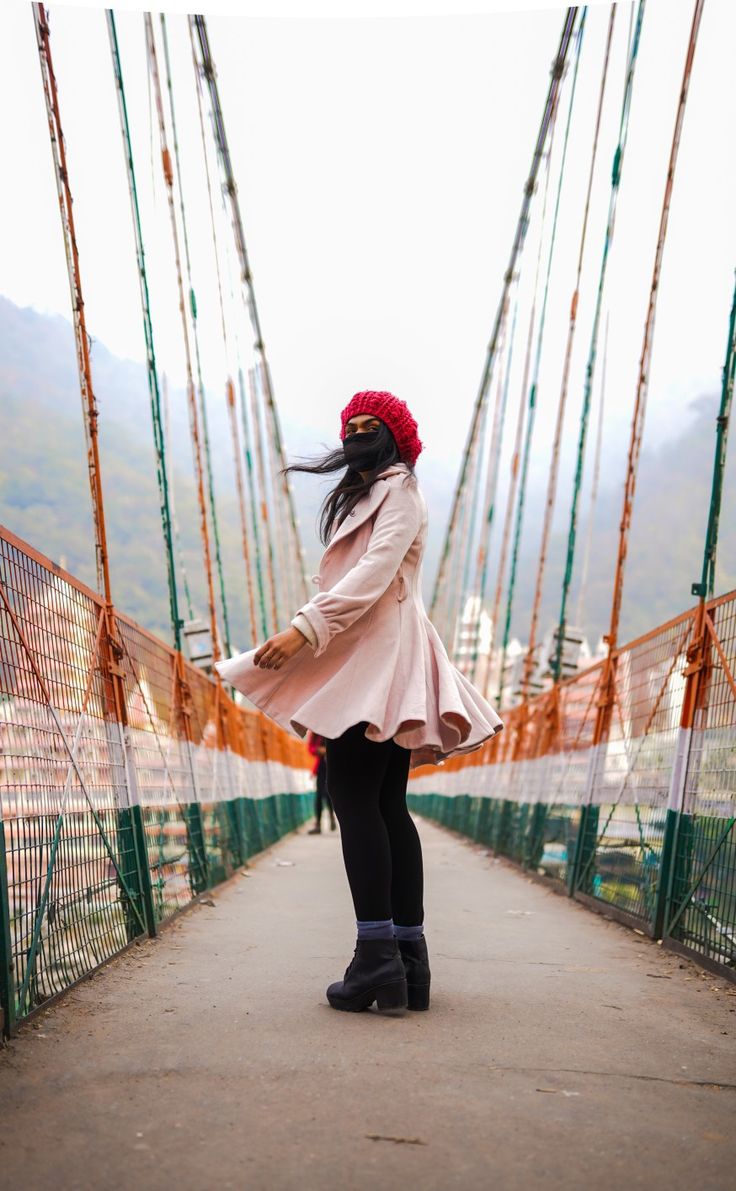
[290,484,424,657]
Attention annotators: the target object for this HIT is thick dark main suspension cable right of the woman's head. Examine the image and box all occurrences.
[430,7,578,633]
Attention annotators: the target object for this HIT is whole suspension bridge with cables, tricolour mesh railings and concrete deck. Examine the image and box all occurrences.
[0,0,736,1189]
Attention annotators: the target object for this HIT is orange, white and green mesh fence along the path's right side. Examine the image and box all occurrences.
[410,593,736,975]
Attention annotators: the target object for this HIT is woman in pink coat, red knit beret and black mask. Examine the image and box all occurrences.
[211,392,503,1011]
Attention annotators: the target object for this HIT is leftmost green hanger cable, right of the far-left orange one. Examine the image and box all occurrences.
[106,8,182,653]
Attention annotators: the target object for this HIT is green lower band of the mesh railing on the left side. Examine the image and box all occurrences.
[0,793,312,1034]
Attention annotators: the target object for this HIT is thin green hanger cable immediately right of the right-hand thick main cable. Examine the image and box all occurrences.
[493,5,587,703]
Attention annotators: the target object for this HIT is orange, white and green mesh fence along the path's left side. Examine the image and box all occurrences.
[0,530,312,1033]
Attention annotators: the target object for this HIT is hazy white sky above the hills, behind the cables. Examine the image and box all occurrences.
[0,0,736,557]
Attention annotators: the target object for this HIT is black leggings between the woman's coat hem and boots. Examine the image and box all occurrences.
[325,722,424,927]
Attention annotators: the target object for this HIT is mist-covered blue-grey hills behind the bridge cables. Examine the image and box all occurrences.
[0,298,736,648]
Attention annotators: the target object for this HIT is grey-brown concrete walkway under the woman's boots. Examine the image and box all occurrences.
[0,824,736,1191]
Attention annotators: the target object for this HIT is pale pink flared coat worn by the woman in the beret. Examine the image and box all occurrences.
[211,463,503,768]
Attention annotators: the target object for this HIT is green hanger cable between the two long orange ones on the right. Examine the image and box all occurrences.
[551,0,647,681]
